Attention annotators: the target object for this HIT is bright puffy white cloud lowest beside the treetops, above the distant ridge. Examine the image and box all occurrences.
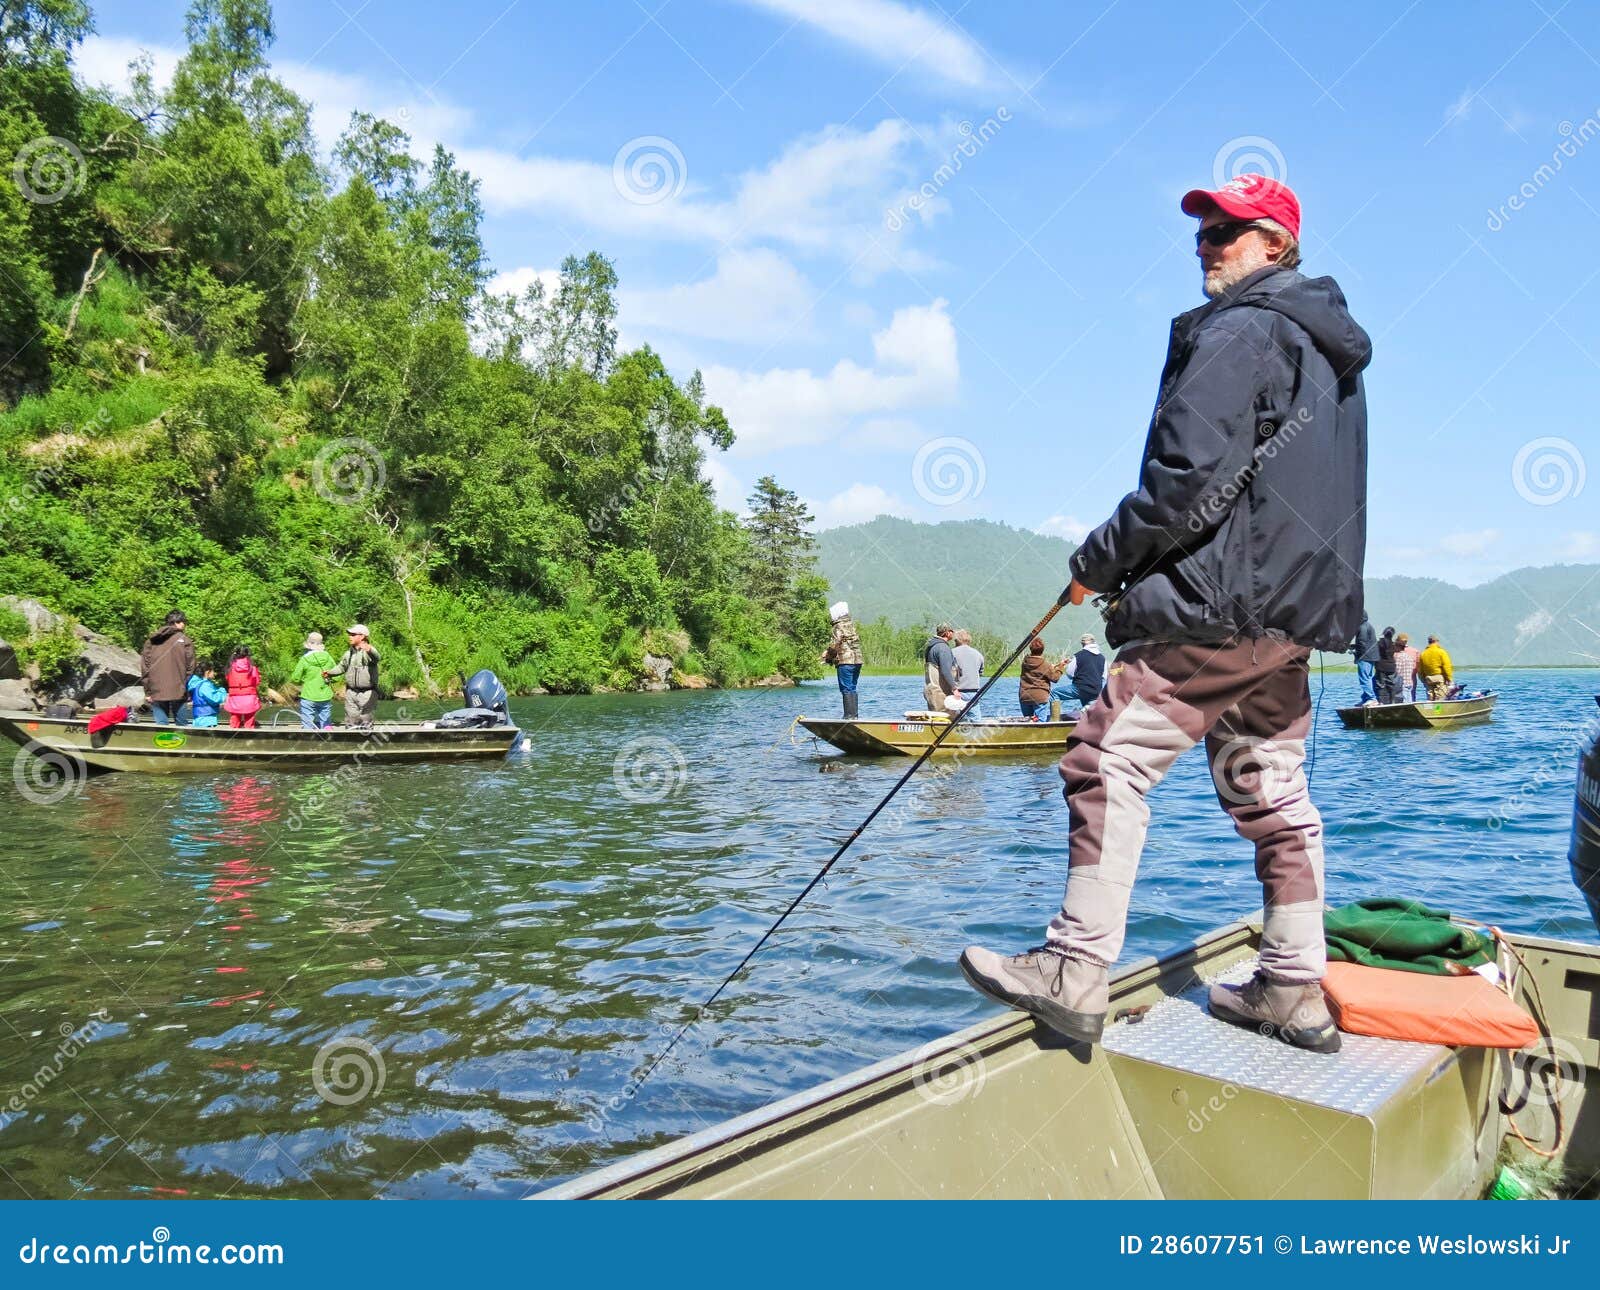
[706,299,960,455]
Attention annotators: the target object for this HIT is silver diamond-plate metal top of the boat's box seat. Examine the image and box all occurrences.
[1102,960,1450,1116]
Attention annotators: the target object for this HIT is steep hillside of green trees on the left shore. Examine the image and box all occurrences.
[0,0,827,691]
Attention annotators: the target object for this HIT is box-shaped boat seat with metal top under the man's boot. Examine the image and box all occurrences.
[1104,959,1501,1199]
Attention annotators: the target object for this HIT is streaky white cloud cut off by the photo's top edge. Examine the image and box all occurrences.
[732,0,997,90]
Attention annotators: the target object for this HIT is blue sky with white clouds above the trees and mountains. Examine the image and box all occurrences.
[80,0,1600,584]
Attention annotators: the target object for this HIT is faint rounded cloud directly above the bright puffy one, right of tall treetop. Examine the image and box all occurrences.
[618,246,816,344]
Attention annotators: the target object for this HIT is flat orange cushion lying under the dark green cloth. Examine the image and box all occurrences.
[1322,963,1539,1048]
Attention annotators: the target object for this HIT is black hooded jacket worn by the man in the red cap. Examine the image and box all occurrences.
[1072,267,1373,651]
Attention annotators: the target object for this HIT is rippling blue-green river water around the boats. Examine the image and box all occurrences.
[0,671,1600,1197]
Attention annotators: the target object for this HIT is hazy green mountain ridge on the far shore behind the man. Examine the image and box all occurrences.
[818,515,1600,666]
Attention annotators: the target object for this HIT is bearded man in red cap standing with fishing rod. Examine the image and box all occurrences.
[962,174,1376,1053]
